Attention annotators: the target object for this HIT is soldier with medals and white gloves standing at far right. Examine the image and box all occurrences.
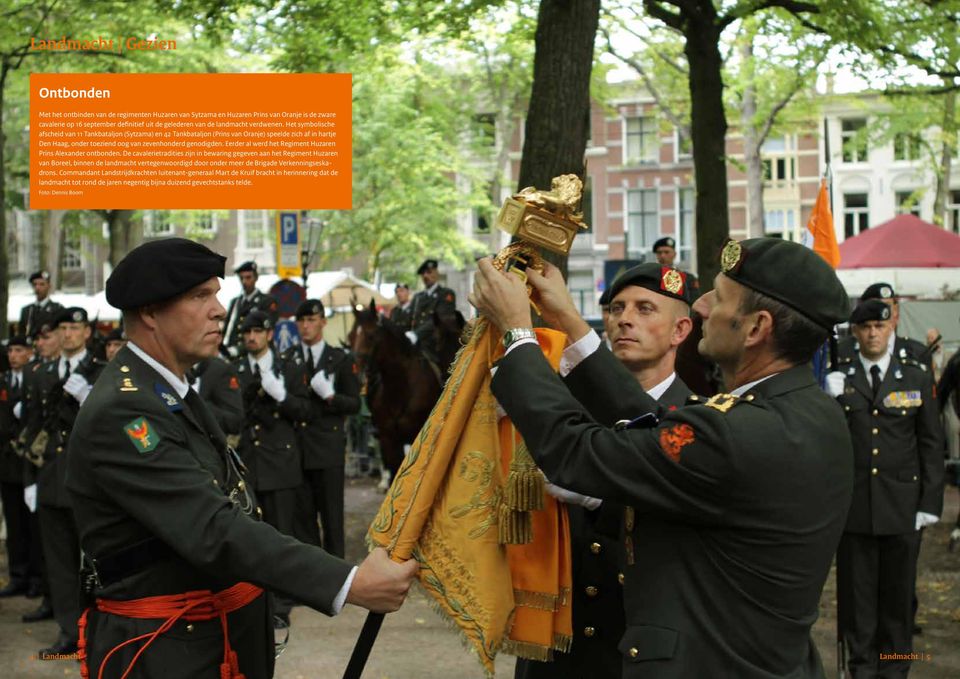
[827,299,944,679]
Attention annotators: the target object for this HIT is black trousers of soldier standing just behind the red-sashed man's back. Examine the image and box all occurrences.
[37,505,80,640]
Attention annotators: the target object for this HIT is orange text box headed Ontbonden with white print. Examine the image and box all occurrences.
[30,73,352,209]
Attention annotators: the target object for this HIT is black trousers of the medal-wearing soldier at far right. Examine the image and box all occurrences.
[837,533,920,679]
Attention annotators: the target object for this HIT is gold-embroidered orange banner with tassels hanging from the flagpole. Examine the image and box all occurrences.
[367,319,573,676]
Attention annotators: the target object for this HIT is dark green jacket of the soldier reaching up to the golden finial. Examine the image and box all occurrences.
[492,345,853,679]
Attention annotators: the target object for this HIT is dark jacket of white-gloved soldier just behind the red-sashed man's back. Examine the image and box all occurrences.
[24,351,104,507]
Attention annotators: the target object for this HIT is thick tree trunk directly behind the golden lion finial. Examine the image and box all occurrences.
[517,0,600,274]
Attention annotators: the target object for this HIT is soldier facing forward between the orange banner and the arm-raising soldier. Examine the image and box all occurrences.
[514,263,692,679]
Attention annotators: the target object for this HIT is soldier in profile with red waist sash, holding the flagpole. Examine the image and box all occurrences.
[67,238,417,679]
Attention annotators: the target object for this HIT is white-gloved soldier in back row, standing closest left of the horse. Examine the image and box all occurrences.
[284,299,360,557]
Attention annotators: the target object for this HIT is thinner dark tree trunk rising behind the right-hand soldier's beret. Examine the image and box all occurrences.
[684,16,730,292]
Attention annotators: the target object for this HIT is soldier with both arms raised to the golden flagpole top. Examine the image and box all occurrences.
[471,238,853,679]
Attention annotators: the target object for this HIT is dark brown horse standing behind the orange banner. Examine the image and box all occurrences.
[348,300,463,486]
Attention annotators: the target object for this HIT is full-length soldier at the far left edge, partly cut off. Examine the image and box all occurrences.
[0,335,43,598]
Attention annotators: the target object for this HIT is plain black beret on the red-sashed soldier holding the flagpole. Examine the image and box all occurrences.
[107,238,227,309]
